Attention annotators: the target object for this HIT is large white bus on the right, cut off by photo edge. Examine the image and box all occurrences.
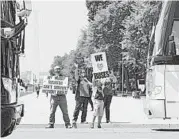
[145,1,179,119]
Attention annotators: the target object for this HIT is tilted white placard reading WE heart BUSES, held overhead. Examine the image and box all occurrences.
[91,52,109,79]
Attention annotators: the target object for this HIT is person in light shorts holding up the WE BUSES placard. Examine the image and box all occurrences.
[91,81,104,128]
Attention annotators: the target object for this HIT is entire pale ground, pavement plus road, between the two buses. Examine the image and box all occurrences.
[4,91,179,139]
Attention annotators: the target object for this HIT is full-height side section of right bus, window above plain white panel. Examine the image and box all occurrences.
[165,1,179,118]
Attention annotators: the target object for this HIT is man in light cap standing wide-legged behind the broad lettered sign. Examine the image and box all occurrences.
[46,66,71,128]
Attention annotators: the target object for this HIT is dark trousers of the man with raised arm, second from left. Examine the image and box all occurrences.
[73,97,89,122]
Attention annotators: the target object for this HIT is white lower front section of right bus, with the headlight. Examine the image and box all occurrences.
[144,65,165,118]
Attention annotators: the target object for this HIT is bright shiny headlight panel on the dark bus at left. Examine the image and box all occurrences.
[2,78,16,103]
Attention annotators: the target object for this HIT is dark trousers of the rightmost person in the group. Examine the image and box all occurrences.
[104,95,112,121]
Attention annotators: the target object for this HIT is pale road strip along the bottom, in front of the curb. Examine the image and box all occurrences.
[6,128,179,139]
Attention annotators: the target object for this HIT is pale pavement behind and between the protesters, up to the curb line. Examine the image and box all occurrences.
[20,91,179,127]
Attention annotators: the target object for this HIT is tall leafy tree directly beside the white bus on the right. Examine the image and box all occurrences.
[122,1,162,88]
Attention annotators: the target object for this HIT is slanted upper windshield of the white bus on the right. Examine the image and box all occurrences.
[153,2,179,56]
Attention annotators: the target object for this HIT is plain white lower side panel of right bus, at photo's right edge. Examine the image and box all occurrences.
[165,65,179,118]
